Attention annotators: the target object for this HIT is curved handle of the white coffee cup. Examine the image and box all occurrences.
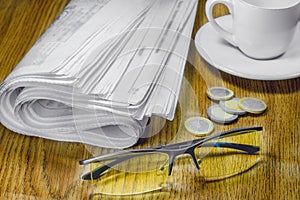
[205,0,237,47]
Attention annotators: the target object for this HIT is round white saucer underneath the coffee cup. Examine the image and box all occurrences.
[195,15,300,80]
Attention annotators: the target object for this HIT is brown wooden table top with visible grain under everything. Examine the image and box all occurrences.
[0,0,300,200]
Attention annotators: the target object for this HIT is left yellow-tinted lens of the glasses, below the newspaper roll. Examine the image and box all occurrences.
[91,153,169,195]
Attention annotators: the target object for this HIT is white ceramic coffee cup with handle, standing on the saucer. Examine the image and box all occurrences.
[205,0,300,59]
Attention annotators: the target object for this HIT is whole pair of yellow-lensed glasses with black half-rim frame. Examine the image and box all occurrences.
[80,127,262,195]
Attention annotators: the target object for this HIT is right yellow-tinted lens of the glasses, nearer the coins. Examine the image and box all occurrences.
[195,131,260,180]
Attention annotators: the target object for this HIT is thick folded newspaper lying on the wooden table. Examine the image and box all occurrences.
[0,0,197,148]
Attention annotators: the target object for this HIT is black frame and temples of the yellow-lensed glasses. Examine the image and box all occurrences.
[79,126,263,180]
